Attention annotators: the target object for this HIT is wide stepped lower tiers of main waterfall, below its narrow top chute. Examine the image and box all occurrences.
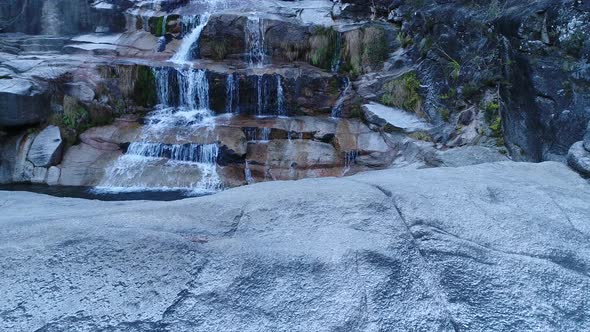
[95,68,221,193]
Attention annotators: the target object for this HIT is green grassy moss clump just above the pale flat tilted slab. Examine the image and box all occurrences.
[381,72,422,115]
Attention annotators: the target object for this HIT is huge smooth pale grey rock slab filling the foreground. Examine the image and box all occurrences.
[0,162,590,331]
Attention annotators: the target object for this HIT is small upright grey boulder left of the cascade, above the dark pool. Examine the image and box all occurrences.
[27,126,63,167]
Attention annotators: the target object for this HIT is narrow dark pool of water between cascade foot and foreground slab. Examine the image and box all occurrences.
[0,183,210,201]
